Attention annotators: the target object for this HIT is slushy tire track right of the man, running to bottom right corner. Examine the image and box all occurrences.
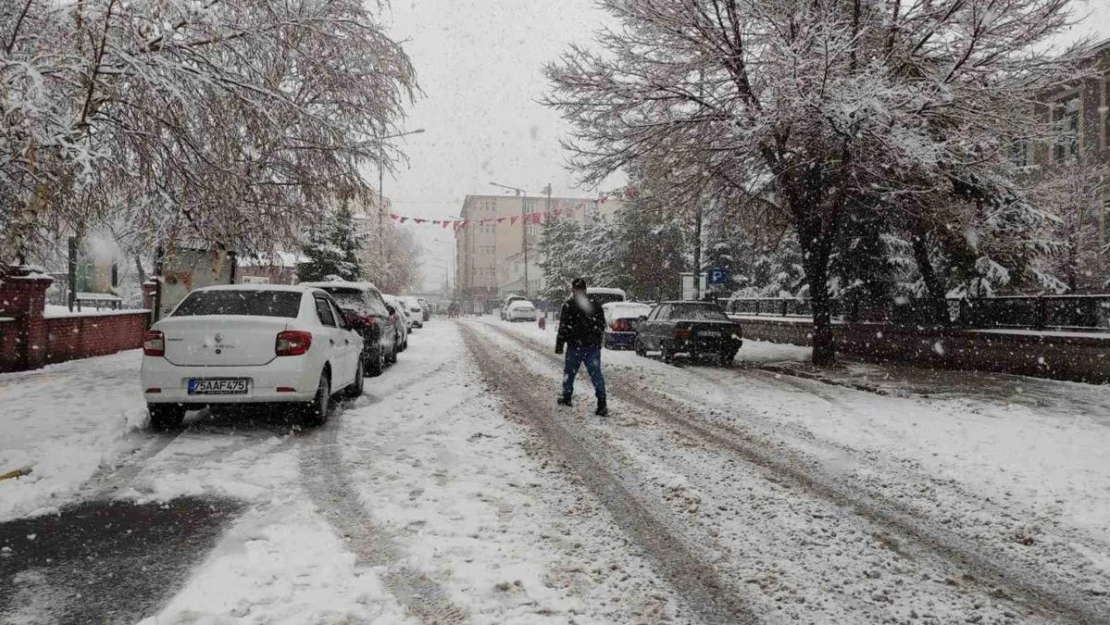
[481,323,1110,625]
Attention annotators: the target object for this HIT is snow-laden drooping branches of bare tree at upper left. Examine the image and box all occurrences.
[0,0,415,263]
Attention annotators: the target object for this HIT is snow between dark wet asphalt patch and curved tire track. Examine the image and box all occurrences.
[133,429,412,625]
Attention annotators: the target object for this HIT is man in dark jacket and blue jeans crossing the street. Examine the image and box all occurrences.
[555,278,609,416]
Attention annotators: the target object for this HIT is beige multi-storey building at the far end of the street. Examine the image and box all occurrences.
[455,195,620,311]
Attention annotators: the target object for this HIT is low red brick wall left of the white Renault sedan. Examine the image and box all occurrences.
[44,311,149,363]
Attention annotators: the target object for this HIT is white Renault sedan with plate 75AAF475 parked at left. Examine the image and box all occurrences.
[140,284,363,430]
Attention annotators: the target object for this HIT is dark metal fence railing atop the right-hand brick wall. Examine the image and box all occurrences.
[723,293,1110,330]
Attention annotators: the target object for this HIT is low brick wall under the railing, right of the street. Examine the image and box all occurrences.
[736,317,1110,384]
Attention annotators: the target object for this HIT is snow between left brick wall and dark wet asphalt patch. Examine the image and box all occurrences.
[0,351,147,521]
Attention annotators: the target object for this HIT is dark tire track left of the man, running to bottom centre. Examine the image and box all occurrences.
[461,324,758,625]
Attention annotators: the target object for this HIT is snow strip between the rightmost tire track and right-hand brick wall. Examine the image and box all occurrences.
[493,313,1110,557]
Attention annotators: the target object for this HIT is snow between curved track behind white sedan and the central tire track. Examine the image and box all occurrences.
[341,322,688,625]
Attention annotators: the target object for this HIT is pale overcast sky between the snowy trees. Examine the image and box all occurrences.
[384,0,1110,288]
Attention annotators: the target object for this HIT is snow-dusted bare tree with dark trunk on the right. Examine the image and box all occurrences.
[548,0,1087,363]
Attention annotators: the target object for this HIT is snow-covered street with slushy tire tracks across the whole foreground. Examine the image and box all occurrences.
[0,317,1110,625]
